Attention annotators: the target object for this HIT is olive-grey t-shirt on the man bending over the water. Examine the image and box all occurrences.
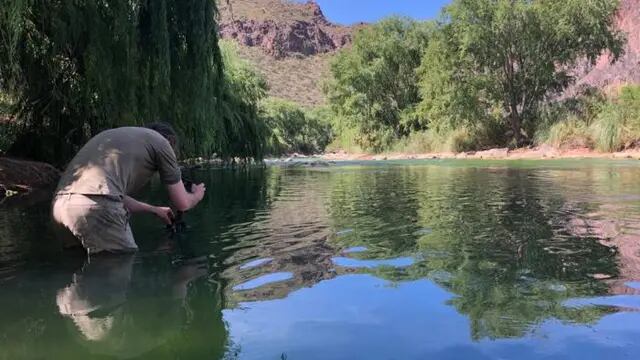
[57,127,181,199]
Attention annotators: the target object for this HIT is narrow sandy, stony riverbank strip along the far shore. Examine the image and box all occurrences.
[320,146,640,161]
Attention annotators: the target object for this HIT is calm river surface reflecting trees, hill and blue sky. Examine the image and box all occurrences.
[0,161,640,359]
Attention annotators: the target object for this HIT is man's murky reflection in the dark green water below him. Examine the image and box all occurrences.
[56,254,214,357]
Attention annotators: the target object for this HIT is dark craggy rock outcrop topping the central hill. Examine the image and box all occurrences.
[220,0,351,58]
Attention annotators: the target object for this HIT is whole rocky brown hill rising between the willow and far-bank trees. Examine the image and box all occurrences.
[219,0,353,106]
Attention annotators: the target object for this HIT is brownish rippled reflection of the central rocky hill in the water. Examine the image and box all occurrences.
[218,168,335,307]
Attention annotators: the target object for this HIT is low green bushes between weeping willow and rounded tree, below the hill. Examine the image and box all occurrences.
[261,98,331,155]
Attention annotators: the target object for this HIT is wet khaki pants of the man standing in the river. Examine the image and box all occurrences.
[53,194,138,254]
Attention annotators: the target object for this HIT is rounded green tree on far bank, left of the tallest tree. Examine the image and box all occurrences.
[325,18,433,151]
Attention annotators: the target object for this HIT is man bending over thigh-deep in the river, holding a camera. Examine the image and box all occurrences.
[53,123,206,254]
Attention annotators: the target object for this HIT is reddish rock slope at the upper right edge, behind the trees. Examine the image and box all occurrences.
[569,0,640,92]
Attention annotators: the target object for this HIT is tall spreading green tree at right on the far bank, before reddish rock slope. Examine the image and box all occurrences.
[443,0,623,144]
